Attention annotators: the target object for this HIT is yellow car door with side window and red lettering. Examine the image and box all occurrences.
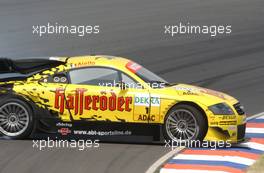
[65,66,134,122]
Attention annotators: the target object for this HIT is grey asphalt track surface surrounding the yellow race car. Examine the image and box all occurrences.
[0,0,264,173]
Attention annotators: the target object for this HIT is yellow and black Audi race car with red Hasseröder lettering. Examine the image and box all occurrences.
[0,56,246,143]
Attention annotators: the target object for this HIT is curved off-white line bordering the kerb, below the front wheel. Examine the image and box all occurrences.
[146,147,185,173]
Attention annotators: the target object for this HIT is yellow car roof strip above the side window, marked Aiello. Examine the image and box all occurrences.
[67,55,130,68]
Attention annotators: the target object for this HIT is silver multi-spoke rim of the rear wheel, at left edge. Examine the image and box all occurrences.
[0,102,29,137]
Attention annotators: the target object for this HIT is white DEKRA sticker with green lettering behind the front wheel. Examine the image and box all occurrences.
[135,94,160,106]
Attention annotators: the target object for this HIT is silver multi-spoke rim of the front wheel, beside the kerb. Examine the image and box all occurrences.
[166,109,199,141]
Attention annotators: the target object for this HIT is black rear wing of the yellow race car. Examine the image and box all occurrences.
[0,57,66,82]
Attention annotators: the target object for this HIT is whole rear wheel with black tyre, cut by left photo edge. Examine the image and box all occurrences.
[0,98,33,139]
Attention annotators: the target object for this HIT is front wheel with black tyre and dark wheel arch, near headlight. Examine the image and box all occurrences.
[163,105,207,142]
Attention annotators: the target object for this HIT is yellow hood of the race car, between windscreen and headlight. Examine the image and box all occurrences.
[164,84,238,105]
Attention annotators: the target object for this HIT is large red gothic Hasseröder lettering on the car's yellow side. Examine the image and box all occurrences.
[54,88,132,115]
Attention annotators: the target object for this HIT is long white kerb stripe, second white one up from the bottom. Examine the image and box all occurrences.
[173,154,255,165]
